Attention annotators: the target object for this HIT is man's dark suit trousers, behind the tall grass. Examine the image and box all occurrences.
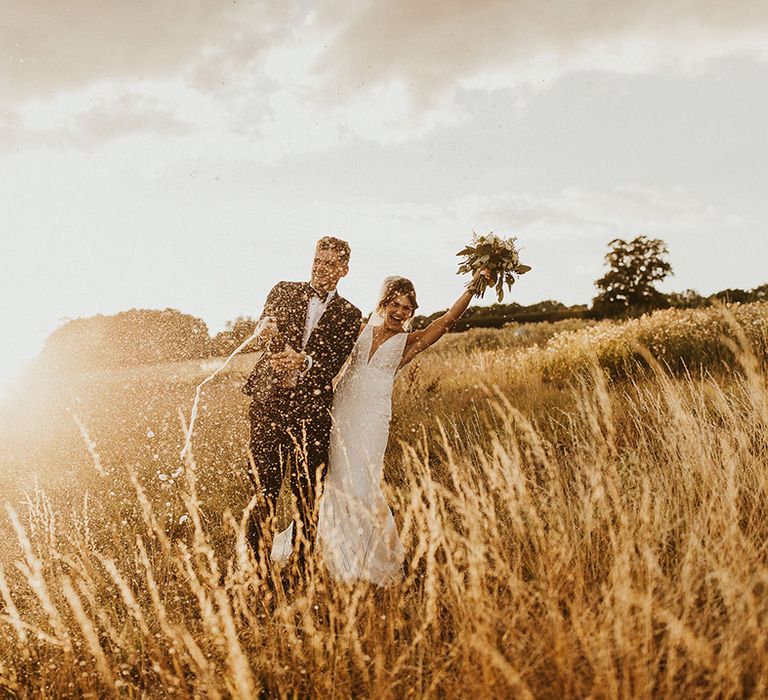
[247,401,331,565]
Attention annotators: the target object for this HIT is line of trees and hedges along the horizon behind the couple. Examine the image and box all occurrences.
[38,236,768,371]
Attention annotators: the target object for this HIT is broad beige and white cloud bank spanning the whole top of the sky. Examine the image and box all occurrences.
[6,0,768,160]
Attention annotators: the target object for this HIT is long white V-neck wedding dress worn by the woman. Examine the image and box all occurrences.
[272,323,408,586]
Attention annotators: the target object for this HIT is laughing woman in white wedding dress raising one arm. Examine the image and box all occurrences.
[271,271,488,586]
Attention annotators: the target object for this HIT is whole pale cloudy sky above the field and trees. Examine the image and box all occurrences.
[0,0,768,387]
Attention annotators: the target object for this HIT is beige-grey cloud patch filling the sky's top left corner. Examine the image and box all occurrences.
[0,0,290,101]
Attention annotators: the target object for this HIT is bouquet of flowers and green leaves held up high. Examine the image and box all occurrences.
[456,231,531,303]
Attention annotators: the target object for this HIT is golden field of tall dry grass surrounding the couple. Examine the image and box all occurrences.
[0,304,768,698]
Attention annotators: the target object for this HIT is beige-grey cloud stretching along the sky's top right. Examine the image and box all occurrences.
[325,0,768,96]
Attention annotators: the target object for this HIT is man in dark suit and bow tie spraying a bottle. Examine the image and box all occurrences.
[243,237,361,566]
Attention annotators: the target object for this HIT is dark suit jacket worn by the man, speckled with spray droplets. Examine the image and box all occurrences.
[243,282,362,422]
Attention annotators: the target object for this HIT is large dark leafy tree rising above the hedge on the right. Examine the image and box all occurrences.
[592,236,672,316]
